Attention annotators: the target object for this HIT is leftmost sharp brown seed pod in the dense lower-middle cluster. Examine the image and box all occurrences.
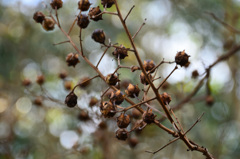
[100,102,116,118]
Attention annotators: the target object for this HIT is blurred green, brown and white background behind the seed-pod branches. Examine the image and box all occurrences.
[0,0,240,159]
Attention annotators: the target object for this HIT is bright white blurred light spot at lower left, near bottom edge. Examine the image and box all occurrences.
[60,131,79,149]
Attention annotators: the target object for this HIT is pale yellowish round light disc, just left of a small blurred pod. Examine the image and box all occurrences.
[16,97,32,114]
